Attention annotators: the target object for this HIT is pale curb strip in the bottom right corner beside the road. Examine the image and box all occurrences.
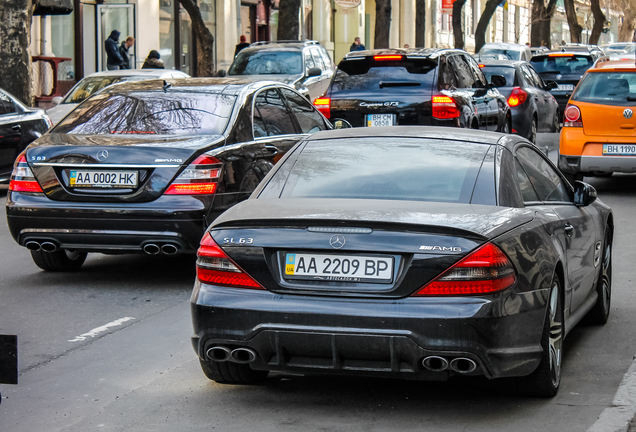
[587,356,636,432]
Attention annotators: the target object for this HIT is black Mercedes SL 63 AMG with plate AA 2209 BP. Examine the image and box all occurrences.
[191,126,613,397]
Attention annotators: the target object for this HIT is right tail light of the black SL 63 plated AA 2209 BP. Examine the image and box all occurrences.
[413,243,516,296]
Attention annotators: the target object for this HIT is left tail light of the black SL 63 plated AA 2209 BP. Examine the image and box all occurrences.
[197,233,265,290]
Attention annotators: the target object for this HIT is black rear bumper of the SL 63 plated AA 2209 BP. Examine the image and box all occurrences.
[191,281,545,380]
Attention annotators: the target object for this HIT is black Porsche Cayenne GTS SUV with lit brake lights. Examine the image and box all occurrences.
[314,48,510,133]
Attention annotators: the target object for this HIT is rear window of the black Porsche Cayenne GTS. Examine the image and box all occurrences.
[332,58,437,93]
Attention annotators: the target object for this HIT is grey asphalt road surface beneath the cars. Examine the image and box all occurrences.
[0,135,636,432]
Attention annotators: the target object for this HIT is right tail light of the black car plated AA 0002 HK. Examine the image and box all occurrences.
[164,154,223,195]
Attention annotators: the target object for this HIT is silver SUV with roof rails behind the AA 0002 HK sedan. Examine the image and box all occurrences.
[219,40,334,101]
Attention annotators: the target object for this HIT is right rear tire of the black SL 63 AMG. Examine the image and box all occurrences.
[518,274,564,398]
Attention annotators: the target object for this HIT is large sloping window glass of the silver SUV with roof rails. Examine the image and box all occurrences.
[228,50,303,75]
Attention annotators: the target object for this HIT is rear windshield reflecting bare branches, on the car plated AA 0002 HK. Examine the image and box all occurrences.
[53,91,236,135]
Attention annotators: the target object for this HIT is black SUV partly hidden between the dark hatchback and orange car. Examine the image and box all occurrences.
[530,44,605,113]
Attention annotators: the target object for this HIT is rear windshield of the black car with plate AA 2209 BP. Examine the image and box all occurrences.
[270,137,486,203]
